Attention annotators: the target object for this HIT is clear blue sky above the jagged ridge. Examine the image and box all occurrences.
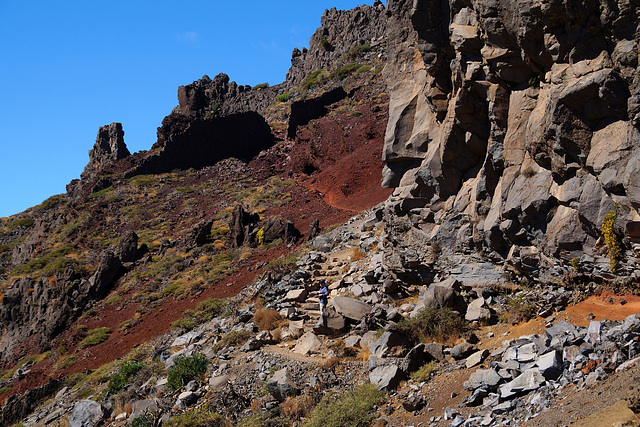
[0,0,380,217]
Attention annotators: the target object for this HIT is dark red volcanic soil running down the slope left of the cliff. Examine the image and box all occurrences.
[5,85,391,399]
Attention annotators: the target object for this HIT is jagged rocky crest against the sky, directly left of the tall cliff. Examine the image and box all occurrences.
[286,0,387,87]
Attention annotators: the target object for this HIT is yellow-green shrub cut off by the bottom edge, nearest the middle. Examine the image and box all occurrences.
[304,384,385,427]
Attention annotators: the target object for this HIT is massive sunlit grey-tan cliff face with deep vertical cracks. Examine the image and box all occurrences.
[383,0,640,256]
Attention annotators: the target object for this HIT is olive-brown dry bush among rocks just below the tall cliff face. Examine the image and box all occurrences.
[398,307,465,342]
